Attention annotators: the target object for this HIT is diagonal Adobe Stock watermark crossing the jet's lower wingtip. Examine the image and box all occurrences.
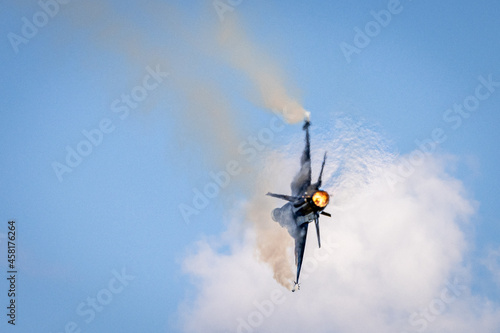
[236,236,340,333]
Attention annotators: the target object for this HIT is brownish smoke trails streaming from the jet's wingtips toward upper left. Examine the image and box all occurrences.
[54,1,307,289]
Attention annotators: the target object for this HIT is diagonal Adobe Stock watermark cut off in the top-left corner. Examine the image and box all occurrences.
[7,0,71,54]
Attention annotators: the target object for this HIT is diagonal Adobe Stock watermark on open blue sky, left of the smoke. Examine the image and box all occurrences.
[52,65,168,182]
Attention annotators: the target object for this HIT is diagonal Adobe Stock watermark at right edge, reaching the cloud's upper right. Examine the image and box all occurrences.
[385,74,500,190]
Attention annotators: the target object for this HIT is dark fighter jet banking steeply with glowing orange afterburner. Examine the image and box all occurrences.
[267,114,331,291]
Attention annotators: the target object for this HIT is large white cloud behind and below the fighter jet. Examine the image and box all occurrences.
[180,116,500,333]
